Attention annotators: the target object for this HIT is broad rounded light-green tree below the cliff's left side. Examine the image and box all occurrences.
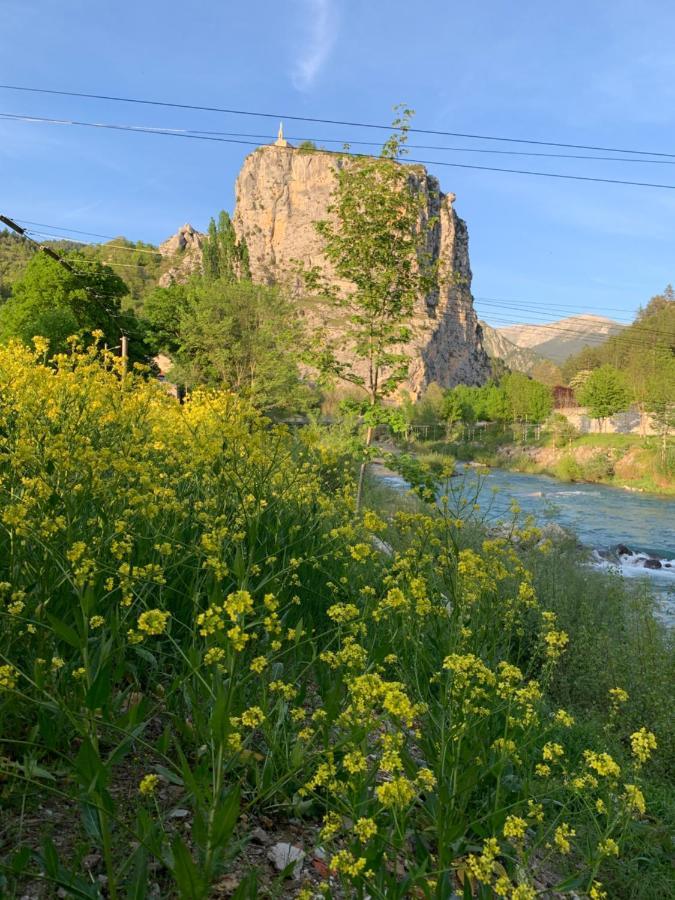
[176,277,312,411]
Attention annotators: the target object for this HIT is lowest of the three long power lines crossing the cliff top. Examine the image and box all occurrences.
[0,112,675,191]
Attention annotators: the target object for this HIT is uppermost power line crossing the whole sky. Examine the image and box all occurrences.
[0,84,675,158]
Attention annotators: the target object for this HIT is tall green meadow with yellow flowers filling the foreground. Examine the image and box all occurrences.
[0,345,672,900]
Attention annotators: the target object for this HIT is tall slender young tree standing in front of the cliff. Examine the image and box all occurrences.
[303,110,435,505]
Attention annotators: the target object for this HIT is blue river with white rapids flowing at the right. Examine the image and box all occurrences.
[374,466,675,626]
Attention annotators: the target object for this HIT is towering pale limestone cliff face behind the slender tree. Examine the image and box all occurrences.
[233,145,490,395]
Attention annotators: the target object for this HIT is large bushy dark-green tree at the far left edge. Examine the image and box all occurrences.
[0,253,147,359]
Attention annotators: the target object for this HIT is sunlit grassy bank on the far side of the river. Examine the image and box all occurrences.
[415,434,675,496]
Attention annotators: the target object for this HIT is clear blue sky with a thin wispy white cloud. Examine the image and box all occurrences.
[0,0,675,325]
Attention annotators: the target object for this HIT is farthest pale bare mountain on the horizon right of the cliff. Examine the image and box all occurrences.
[496,313,624,364]
